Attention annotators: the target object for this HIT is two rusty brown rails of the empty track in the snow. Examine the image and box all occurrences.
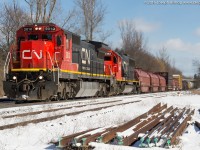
[0,100,140,130]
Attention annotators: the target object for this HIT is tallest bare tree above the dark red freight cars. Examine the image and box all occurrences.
[119,20,157,71]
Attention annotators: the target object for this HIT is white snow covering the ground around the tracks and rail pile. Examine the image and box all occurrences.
[0,92,200,150]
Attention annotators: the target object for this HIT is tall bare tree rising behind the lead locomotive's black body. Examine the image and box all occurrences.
[75,0,106,40]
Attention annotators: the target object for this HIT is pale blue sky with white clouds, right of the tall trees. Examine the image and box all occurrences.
[4,0,200,76]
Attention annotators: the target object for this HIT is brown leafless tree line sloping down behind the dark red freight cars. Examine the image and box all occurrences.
[118,20,182,75]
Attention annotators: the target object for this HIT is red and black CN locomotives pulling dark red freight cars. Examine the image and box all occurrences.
[3,23,181,100]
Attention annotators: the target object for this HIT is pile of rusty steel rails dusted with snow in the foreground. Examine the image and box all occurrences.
[54,103,194,149]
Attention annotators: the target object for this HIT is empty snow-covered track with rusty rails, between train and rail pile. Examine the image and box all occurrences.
[0,93,183,130]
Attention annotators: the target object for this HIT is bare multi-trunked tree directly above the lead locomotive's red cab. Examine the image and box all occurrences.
[24,0,77,30]
